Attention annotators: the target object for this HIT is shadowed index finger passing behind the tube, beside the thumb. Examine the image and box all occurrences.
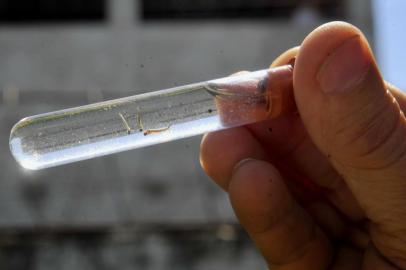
[249,46,364,220]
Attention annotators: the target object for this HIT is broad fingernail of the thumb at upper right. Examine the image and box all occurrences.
[317,35,371,93]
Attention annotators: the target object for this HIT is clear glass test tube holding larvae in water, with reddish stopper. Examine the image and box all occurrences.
[10,65,294,170]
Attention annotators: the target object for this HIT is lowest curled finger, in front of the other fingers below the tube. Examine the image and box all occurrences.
[228,160,332,270]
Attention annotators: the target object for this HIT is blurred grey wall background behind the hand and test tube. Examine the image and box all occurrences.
[0,0,400,270]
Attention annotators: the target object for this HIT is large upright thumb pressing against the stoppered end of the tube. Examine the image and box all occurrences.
[294,22,406,267]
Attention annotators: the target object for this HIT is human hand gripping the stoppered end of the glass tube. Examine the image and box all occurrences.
[201,22,406,270]
